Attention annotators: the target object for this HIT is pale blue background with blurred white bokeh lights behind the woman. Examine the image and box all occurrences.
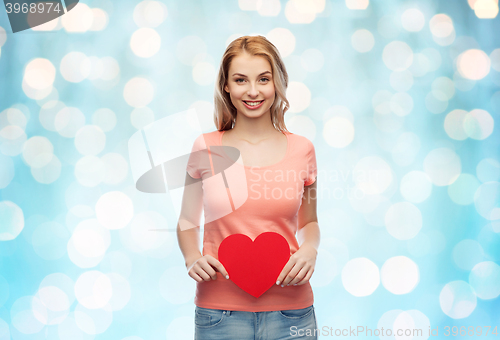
[0,0,500,340]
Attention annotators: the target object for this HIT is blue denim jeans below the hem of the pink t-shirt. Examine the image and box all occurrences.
[194,305,319,340]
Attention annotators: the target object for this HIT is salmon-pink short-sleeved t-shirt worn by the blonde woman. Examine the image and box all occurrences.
[187,130,317,312]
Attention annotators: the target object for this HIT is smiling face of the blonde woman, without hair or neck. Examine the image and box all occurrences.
[224,53,275,118]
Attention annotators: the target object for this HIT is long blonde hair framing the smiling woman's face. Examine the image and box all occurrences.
[214,35,290,132]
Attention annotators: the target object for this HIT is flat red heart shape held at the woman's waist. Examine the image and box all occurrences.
[219,231,290,298]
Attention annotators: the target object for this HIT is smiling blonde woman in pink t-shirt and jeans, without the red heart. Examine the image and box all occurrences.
[177,36,320,340]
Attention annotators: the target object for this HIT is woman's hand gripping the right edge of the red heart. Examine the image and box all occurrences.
[277,244,318,287]
